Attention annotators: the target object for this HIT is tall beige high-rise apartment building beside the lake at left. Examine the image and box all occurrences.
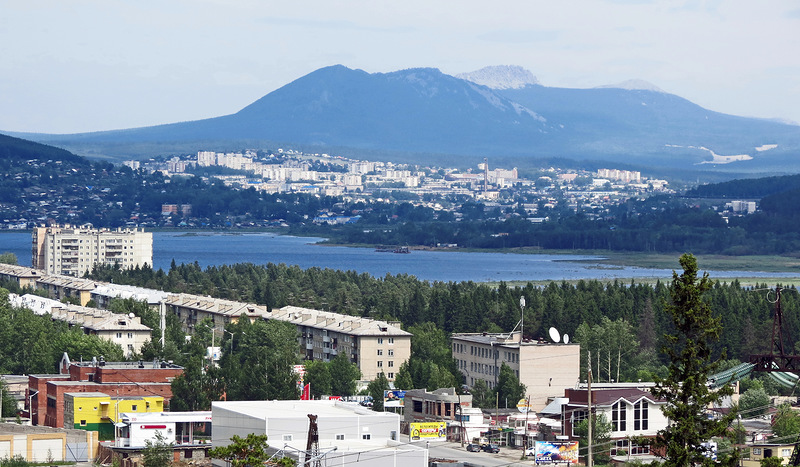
[31,226,153,277]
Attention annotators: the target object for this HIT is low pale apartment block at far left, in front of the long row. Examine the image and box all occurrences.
[8,294,152,357]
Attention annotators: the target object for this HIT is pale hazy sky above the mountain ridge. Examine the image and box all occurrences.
[0,0,800,133]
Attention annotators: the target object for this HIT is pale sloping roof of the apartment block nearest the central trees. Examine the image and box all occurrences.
[265,306,411,336]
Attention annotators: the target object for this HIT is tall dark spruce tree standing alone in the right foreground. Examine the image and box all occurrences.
[651,254,736,466]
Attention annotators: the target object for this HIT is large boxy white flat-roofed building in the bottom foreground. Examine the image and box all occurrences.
[211,401,428,467]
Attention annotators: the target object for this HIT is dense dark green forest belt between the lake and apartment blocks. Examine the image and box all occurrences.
[92,263,800,387]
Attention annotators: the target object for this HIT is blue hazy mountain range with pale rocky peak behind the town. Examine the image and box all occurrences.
[7,65,800,172]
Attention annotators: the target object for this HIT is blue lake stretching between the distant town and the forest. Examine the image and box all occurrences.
[0,232,797,282]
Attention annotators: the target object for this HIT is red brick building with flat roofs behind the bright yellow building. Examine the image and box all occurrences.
[28,354,183,428]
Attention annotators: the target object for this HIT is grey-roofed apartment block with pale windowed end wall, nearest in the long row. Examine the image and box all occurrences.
[264,306,411,381]
